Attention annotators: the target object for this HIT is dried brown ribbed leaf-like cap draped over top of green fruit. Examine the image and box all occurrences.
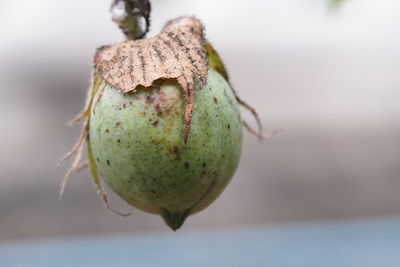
[95,17,208,142]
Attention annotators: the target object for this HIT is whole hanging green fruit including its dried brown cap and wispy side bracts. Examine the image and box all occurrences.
[60,12,261,230]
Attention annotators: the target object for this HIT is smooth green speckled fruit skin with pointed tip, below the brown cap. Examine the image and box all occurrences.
[89,68,242,229]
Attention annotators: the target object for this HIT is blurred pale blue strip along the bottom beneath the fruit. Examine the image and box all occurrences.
[0,218,400,267]
